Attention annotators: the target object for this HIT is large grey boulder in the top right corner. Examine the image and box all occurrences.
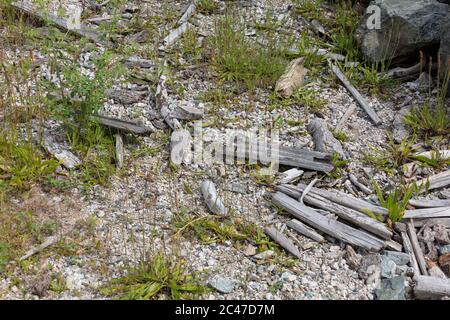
[355,0,450,62]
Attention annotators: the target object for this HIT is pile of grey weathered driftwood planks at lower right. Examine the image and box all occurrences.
[266,170,450,299]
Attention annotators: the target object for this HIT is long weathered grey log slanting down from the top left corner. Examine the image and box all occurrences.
[11,1,112,46]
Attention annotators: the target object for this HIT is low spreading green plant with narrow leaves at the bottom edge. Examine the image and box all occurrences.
[109,252,206,300]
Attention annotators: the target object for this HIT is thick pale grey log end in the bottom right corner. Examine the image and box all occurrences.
[414,275,450,300]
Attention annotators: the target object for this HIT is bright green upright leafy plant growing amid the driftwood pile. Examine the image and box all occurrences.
[372,180,419,223]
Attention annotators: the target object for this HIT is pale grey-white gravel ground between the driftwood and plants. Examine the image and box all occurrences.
[0,0,448,300]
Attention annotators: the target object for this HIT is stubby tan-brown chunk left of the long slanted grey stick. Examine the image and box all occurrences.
[275,57,308,98]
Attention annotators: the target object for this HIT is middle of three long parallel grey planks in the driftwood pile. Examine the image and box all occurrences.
[276,185,392,239]
